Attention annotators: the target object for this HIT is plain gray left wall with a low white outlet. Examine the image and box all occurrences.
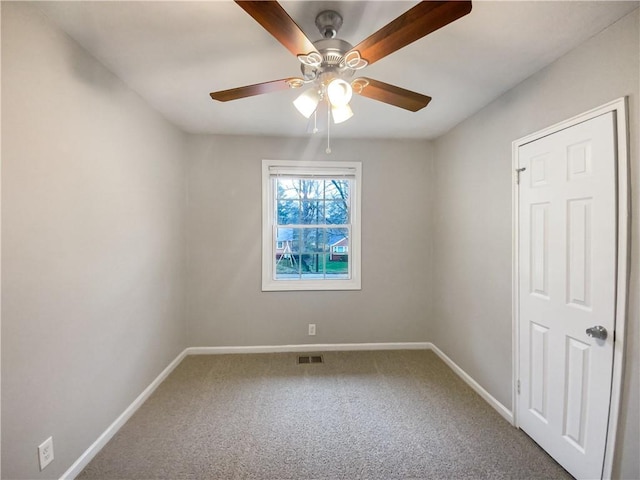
[2,2,186,479]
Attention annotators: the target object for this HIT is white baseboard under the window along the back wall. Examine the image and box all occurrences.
[185,342,431,355]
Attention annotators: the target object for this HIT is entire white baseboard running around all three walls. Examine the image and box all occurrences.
[60,342,513,480]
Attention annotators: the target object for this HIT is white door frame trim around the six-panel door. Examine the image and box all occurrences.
[511,97,630,478]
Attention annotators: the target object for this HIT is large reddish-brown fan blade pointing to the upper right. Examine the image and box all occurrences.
[352,0,471,65]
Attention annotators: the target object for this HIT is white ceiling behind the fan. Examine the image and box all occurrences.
[37,1,639,138]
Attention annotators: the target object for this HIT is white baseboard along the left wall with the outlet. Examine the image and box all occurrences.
[60,350,186,480]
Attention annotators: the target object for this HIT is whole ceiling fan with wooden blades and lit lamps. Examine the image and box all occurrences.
[210,0,471,123]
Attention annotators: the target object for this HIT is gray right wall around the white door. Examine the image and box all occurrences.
[429,10,640,479]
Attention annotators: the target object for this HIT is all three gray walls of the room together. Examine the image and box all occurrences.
[2,2,640,478]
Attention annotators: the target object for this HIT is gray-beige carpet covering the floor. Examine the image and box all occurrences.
[78,351,571,480]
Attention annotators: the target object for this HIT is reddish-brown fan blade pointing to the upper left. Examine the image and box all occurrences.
[236,1,316,55]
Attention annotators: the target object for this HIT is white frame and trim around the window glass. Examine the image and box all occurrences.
[262,160,362,292]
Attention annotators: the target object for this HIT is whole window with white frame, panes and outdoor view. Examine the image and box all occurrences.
[262,160,361,291]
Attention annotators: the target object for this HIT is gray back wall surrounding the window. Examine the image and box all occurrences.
[187,136,432,346]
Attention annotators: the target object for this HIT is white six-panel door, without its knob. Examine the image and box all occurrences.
[517,113,617,478]
